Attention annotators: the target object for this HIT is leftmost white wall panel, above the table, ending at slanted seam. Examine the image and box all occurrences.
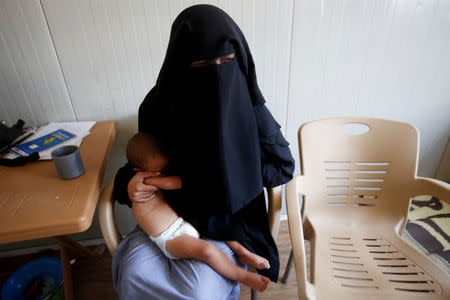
[0,0,75,126]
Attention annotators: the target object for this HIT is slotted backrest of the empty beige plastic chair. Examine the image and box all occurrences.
[298,117,419,230]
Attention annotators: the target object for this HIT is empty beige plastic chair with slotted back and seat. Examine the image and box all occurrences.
[286,118,450,300]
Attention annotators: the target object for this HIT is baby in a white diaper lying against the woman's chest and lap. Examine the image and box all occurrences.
[126,133,270,292]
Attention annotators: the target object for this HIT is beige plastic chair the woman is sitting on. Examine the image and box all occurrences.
[99,172,281,300]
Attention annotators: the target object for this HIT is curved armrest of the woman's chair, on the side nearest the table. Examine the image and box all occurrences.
[98,176,122,255]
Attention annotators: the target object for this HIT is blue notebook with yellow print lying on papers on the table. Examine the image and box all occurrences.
[9,129,76,156]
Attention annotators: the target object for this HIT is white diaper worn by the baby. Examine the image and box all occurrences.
[149,217,200,259]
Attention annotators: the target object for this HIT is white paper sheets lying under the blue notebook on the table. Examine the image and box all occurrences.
[5,121,95,160]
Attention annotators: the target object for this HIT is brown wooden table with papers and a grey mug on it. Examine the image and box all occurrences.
[0,121,116,300]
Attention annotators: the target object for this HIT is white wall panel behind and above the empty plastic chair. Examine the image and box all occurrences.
[287,0,450,176]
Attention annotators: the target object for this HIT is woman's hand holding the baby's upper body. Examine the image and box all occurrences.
[127,171,160,202]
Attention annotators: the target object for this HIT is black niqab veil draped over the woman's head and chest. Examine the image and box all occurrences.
[139,5,265,214]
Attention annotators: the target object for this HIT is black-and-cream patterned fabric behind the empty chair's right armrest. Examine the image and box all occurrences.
[402,196,450,273]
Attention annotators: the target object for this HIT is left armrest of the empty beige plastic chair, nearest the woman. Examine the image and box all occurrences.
[286,176,315,300]
